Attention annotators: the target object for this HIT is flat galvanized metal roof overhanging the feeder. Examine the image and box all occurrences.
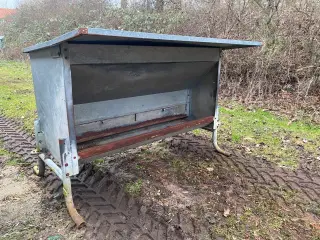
[23,28,262,53]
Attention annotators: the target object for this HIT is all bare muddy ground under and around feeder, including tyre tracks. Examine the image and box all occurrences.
[0,117,320,240]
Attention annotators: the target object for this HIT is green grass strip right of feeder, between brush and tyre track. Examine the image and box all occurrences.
[220,103,320,168]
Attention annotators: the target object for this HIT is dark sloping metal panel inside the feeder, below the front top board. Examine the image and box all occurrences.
[71,62,216,104]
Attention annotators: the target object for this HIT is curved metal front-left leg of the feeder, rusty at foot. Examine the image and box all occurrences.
[59,139,85,228]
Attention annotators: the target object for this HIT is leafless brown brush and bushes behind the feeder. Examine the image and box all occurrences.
[0,0,320,108]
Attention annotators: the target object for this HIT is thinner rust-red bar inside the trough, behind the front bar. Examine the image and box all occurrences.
[77,114,187,143]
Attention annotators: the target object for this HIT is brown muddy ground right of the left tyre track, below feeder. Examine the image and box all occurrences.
[93,135,320,239]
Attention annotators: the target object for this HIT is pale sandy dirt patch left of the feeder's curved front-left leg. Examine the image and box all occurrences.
[0,156,84,240]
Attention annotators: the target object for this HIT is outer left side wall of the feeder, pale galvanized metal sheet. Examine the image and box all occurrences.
[30,47,69,163]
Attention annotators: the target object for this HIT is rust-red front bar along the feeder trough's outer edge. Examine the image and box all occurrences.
[79,116,213,159]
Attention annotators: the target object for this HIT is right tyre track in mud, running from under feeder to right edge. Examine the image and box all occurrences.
[169,134,320,207]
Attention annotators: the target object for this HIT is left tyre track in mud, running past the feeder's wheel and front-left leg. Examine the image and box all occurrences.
[0,116,185,240]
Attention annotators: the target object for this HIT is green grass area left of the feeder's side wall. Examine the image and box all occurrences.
[0,61,36,132]
